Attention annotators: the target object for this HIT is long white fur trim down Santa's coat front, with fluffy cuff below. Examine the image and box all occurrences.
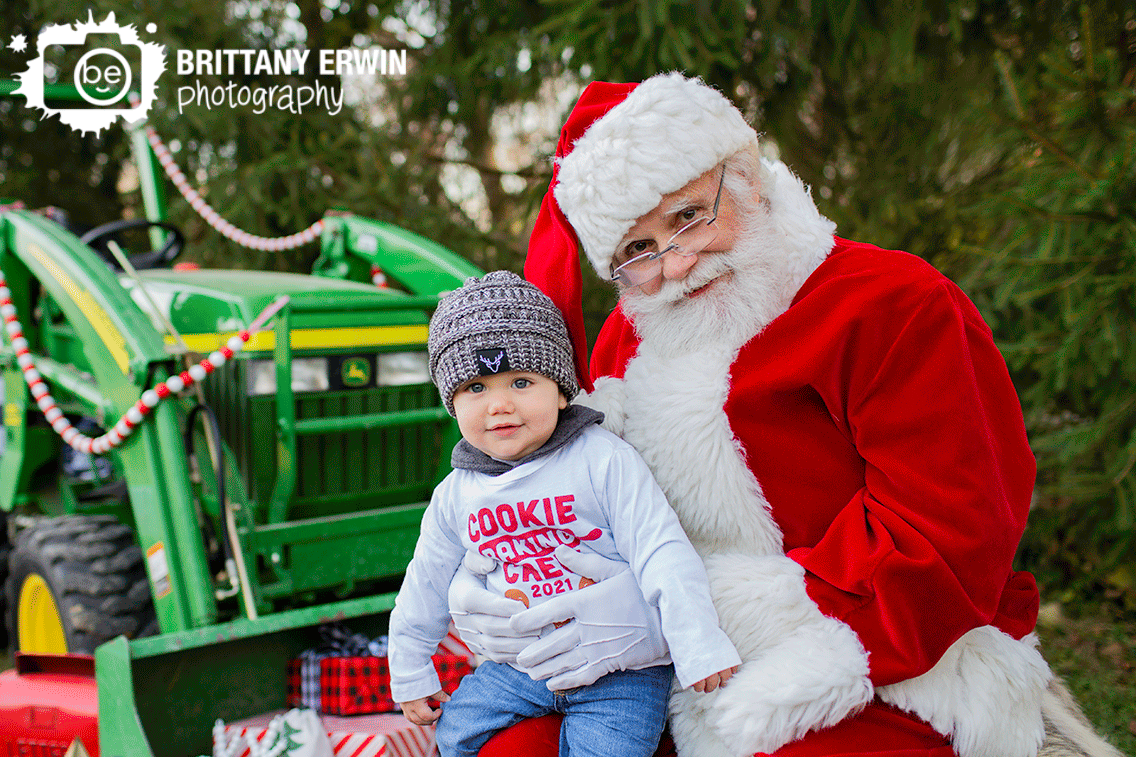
[584,344,872,757]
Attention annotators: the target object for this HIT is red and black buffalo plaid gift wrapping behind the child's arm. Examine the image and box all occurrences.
[289,655,473,715]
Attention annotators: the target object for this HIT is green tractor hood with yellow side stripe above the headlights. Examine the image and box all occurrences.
[120,269,428,352]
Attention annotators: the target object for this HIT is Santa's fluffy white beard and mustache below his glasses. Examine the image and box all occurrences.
[623,206,813,355]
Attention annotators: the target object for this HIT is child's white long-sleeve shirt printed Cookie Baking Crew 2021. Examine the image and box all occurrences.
[390,425,740,701]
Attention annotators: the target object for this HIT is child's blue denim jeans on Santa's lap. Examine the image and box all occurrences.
[436,662,675,757]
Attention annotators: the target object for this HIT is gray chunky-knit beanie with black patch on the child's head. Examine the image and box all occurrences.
[427,271,579,415]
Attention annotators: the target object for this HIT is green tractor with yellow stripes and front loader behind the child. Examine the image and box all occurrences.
[0,79,481,756]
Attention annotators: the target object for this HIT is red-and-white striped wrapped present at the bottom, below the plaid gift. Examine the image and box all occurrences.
[215,713,437,757]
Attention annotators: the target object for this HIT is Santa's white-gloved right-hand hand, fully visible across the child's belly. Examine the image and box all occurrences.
[511,546,669,691]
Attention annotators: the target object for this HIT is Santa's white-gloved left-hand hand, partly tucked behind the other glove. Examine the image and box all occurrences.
[449,552,538,663]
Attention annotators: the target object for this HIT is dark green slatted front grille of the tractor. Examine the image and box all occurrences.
[199,360,443,519]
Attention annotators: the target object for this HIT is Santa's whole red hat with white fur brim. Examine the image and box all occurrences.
[525,73,758,391]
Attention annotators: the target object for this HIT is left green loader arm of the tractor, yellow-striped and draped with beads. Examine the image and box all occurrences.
[0,210,217,631]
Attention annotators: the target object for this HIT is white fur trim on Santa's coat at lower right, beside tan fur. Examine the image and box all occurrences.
[876,625,1053,757]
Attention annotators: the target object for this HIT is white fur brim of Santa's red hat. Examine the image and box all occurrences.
[553,73,758,277]
